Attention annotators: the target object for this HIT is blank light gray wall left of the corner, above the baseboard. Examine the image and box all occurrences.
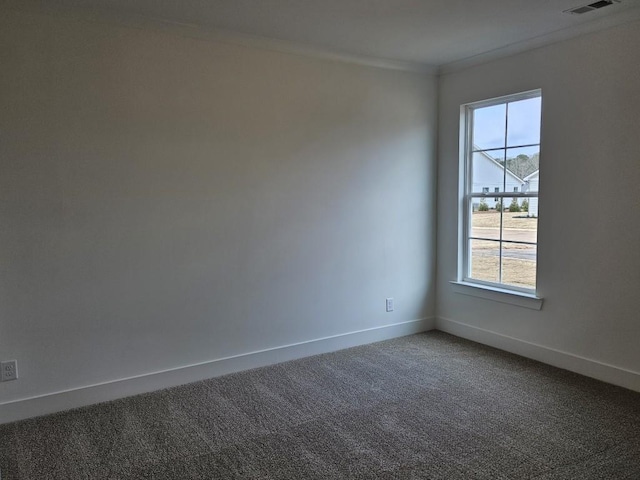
[0,12,436,401]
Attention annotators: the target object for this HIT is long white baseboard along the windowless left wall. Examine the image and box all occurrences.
[0,317,435,424]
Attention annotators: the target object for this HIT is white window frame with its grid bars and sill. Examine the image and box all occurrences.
[454,89,542,298]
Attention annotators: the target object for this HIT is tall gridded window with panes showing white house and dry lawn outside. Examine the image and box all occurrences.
[461,90,542,294]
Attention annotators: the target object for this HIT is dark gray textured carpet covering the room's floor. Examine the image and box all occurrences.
[0,332,640,480]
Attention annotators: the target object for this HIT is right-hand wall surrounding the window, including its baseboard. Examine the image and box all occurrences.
[437,22,640,390]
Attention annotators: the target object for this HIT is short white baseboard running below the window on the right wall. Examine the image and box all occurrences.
[436,317,640,392]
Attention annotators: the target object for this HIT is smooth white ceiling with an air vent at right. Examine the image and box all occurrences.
[21,0,640,67]
